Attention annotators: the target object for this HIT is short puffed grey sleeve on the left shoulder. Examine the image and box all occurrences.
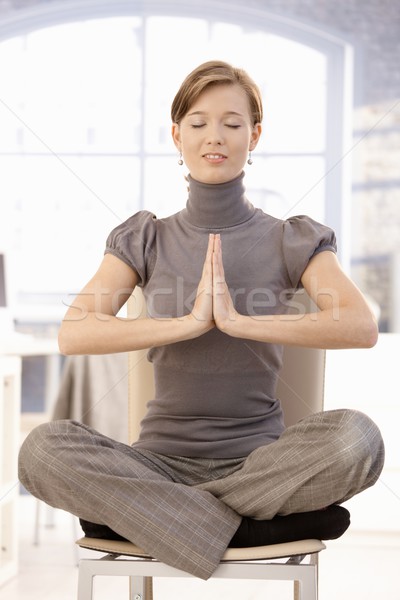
[104,210,157,286]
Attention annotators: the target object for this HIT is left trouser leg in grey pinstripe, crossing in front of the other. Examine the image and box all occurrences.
[19,421,241,579]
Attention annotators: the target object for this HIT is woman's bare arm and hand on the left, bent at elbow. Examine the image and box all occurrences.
[58,242,214,354]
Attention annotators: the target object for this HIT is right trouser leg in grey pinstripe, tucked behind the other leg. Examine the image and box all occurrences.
[198,410,384,519]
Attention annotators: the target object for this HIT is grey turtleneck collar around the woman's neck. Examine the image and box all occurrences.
[182,171,255,229]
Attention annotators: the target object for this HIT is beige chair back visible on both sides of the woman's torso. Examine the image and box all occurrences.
[128,287,325,443]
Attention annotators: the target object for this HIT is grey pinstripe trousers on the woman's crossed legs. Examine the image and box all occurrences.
[19,410,384,579]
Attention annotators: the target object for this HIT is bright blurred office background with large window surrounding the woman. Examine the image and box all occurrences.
[0,0,400,600]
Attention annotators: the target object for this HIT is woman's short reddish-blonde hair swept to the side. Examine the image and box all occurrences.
[171,60,263,125]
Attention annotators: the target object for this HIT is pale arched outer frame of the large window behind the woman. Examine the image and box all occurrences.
[0,0,354,271]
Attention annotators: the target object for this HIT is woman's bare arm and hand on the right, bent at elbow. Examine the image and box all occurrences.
[213,236,378,348]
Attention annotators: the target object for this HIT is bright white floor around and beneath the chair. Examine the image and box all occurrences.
[0,495,400,600]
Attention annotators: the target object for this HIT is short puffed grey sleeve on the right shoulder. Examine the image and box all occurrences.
[282,215,337,288]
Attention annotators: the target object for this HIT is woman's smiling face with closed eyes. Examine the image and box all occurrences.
[172,84,261,183]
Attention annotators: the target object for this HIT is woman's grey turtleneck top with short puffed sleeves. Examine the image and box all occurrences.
[105,173,336,458]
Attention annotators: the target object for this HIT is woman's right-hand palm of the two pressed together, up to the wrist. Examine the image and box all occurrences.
[212,234,238,333]
